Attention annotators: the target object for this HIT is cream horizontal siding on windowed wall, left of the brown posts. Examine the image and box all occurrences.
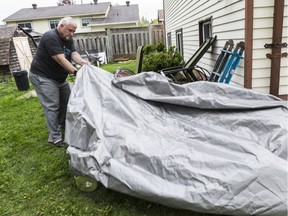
[164,0,245,86]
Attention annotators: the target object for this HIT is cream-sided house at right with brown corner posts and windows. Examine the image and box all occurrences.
[163,0,288,99]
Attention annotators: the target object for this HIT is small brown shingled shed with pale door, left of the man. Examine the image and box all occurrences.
[0,26,37,80]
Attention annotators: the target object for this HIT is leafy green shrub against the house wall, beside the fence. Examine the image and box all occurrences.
[142,43,184,72]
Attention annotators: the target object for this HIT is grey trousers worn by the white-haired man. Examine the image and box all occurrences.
[29,72,71,143]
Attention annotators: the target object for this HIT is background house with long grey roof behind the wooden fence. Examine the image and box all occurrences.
[3,1,139,33]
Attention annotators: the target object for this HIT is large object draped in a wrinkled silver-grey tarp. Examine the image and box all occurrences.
[65,65,287,216]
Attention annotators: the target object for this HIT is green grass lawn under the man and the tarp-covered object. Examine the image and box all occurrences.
[0,62,216,216]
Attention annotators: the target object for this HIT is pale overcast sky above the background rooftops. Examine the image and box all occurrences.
[0,0,163,25]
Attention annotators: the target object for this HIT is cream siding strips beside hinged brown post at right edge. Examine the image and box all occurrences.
[252,0,288,95]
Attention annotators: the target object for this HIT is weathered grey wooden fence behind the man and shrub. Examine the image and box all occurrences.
[73,24,165,61]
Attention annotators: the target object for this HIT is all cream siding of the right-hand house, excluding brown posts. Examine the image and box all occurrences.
[164,0,288,95]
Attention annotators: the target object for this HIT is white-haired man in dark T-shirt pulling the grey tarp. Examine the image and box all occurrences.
[29,17,89,148]
